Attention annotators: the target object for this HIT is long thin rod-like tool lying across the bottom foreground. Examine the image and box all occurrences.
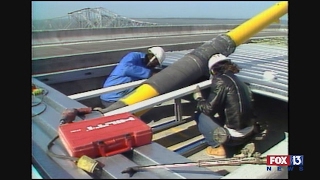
[121,152,267,177]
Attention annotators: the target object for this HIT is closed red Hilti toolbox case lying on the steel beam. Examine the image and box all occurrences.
[58,113,152,158]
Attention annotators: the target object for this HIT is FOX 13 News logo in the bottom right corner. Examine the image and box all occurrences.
[267,155,304,171]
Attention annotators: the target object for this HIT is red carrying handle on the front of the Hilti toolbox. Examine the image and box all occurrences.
[97,134,132,157]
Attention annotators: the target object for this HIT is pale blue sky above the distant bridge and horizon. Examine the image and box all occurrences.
[31,1,288,20]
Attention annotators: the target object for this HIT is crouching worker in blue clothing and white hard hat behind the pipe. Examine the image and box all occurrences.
[100,47,165,108]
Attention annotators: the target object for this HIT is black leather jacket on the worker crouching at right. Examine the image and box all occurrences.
[197,71,254,130]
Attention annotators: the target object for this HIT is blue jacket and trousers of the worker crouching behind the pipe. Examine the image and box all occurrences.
[100,52,152,102]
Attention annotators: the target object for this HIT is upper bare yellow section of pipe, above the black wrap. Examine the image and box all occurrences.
[227,1,288,46]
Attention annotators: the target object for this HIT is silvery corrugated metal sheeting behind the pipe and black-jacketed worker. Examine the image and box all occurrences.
[163,43,288,101]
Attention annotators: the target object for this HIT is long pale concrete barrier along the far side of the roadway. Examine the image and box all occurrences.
[32,24,284,46]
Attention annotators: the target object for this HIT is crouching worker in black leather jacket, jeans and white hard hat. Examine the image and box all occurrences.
[193,54,255,158]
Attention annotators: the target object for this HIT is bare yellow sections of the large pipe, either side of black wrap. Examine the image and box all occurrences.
[115,1,288,112]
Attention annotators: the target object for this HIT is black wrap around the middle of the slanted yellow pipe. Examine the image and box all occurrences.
[144,35,236,94]
